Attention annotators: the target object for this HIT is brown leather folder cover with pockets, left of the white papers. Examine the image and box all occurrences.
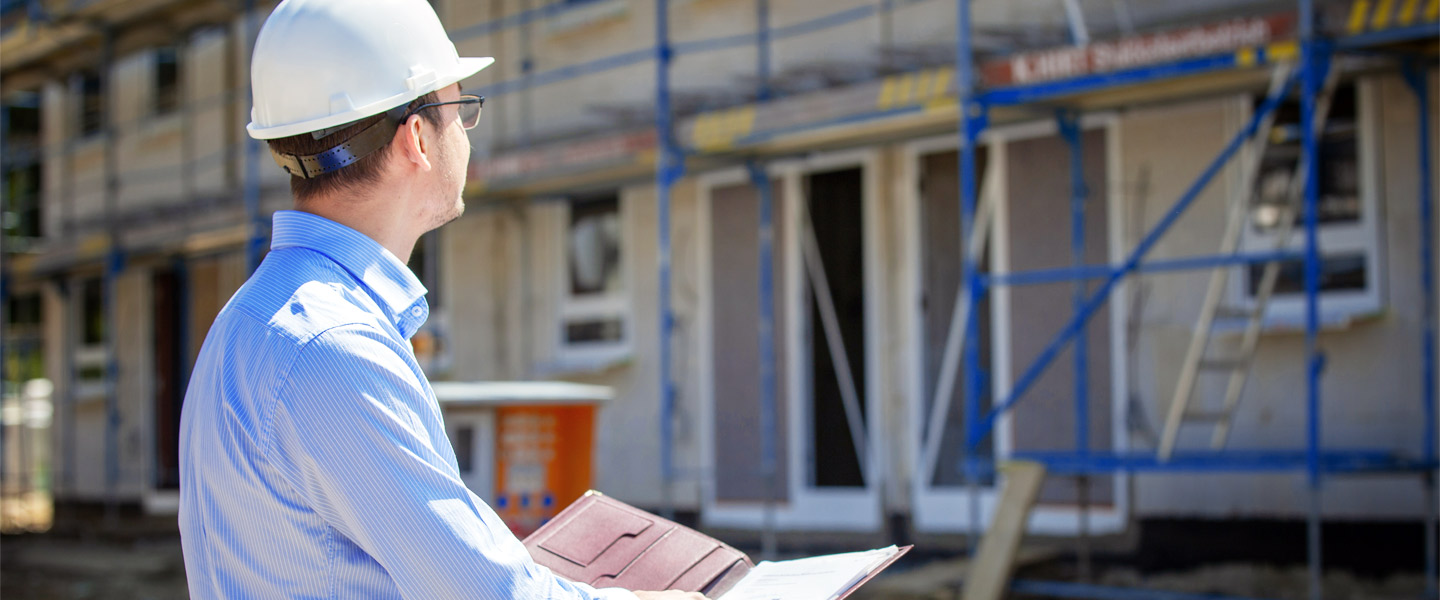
[524,491,753,597]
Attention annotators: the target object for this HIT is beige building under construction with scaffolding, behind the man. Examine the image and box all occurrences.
[0,0,1440,597]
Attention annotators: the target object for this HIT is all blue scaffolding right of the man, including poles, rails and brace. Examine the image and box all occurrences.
[501,0,1440,599]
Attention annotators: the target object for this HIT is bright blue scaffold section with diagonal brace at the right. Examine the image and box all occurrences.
[956,0,1437,592]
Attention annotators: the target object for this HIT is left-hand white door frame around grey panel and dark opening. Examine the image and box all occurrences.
[696,148,884,531]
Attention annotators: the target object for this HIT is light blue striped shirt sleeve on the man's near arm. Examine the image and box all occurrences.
[262,325,635,600]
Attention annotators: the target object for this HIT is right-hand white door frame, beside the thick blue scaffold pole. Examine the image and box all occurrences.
[900,114,1129,535]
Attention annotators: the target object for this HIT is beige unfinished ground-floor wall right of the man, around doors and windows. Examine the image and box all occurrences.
[446,67,1420,518]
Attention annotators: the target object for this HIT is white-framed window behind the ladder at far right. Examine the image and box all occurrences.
[1231,82,1382,325]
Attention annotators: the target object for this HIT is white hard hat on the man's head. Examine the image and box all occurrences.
[245,0,495,140]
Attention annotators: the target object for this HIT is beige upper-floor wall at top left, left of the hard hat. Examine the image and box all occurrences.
[42,10,272,233]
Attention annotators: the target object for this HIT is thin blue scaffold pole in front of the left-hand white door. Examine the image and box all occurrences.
[746,161,779,560]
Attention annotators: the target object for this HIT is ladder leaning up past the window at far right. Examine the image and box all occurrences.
[1158,65,1339,460]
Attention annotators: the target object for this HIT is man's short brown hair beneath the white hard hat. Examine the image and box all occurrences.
[269,92,444,201]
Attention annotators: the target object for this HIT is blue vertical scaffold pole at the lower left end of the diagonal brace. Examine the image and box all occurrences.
[955,0,985,546]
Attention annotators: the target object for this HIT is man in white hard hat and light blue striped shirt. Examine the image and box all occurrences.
[180,0,701,600]
